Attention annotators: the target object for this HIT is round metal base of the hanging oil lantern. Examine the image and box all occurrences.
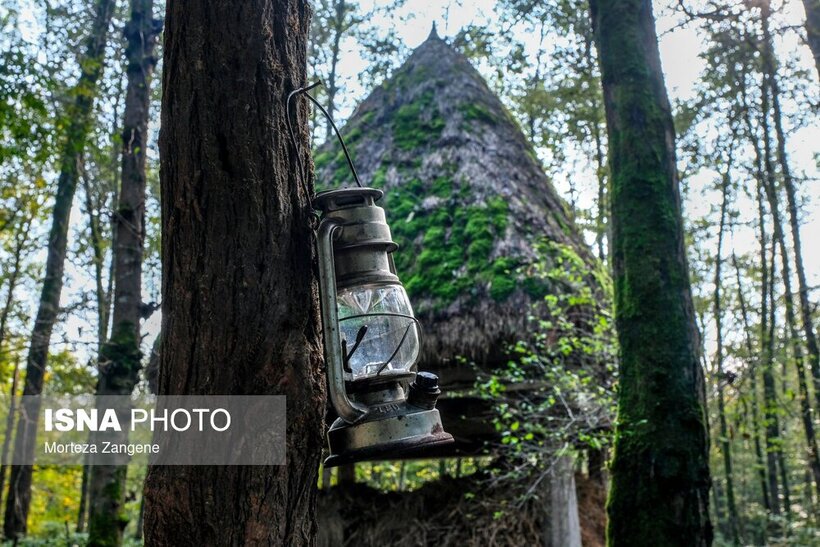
[325,405,454,467]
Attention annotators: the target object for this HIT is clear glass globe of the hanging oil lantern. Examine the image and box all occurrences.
[336,284,420,382]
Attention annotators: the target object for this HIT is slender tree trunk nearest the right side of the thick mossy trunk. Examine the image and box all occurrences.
[714,170,740,545]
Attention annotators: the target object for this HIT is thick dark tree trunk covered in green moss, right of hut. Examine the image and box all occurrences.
[590,0,712,546]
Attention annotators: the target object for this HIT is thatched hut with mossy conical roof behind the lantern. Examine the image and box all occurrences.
[314,30,606,545]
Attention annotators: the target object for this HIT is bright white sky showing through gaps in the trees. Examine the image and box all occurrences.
[11,0,820,368]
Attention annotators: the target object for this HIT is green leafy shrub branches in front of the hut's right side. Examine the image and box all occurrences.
[477,241,616,488]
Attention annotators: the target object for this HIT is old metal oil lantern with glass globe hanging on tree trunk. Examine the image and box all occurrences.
[314,188,453,466]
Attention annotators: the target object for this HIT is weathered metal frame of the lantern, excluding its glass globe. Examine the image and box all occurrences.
[314,188,454,467]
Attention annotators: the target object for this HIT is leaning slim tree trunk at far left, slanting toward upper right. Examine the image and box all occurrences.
[3,0,115,539]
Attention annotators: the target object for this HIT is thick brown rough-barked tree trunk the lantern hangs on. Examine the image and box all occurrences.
[144,0,325,547]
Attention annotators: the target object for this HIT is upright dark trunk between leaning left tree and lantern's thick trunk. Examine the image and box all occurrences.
[88,0,162,546]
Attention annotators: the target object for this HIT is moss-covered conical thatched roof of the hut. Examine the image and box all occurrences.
[315,33,594,368]
